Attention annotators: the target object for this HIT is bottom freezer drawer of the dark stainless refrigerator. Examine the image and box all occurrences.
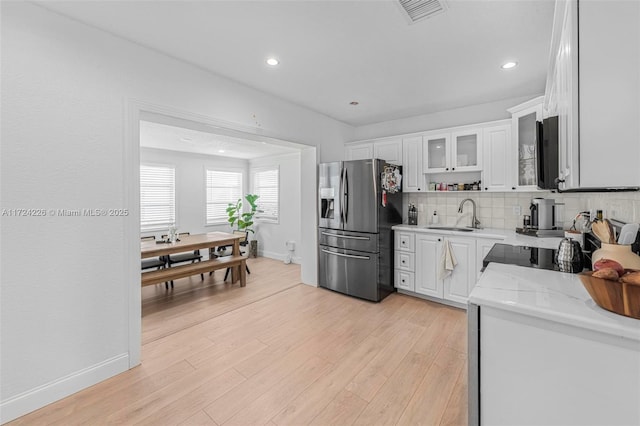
[319,245,380,302]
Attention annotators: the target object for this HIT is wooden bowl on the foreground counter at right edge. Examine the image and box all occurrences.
[578,271,640,319]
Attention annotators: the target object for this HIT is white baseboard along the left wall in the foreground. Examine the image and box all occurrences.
[0,354,129,424]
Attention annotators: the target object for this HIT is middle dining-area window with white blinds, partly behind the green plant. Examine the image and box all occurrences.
[206,170,242,225]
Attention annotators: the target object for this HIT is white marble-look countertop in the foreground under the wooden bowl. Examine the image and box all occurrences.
[469,263,640,343]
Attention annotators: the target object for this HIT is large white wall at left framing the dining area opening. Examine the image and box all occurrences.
[0,2,353,421]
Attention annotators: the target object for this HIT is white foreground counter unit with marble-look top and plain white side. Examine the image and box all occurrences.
[468,263,640,425]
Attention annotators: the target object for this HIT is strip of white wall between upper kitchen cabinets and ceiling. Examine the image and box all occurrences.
[352,93,540,141]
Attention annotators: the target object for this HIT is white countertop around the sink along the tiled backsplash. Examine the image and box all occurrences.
[392,224,562,249]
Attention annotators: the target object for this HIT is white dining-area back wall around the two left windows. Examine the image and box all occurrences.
[140,148,249,238]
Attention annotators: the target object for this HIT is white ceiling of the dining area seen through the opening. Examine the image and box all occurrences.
[140,120,300,160]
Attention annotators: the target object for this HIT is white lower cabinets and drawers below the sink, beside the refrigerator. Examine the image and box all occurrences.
[395,234,476,305]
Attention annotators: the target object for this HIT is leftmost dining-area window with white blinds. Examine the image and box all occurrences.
[140,164,176,231]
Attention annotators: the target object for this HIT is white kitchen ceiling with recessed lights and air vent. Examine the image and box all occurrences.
[40,0,554,126]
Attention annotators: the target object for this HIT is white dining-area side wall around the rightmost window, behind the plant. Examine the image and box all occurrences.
[249,153,301,263]
